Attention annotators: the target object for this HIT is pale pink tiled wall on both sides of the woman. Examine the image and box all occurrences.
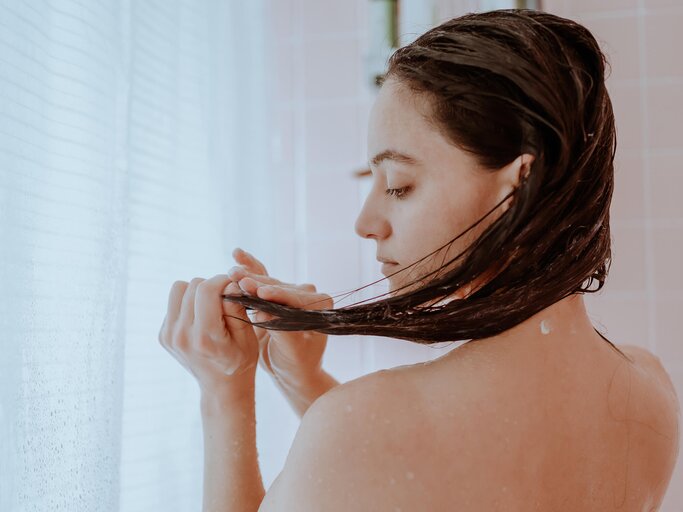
[267,0,683,504]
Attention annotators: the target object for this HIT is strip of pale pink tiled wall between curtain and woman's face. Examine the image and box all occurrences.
[267,0,367,388]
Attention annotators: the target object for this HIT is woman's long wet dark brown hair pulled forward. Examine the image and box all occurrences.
[223,9,630,360]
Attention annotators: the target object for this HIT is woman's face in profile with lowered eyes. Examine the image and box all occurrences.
[355,79,533,294]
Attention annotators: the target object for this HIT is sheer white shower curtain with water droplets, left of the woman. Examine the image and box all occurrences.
[0,0,284,512]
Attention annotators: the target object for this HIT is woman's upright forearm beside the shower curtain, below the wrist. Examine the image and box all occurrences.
[201,386,265,512]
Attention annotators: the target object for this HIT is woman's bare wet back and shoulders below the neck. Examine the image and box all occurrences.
[259,345,679,512]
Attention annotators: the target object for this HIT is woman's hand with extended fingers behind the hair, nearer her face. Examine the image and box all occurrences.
[228,249,334,387]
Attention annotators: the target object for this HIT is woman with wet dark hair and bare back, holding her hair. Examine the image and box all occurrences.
[160,10,679,512]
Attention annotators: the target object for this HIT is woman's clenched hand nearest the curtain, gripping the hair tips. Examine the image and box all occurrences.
[159,274,259,393]
